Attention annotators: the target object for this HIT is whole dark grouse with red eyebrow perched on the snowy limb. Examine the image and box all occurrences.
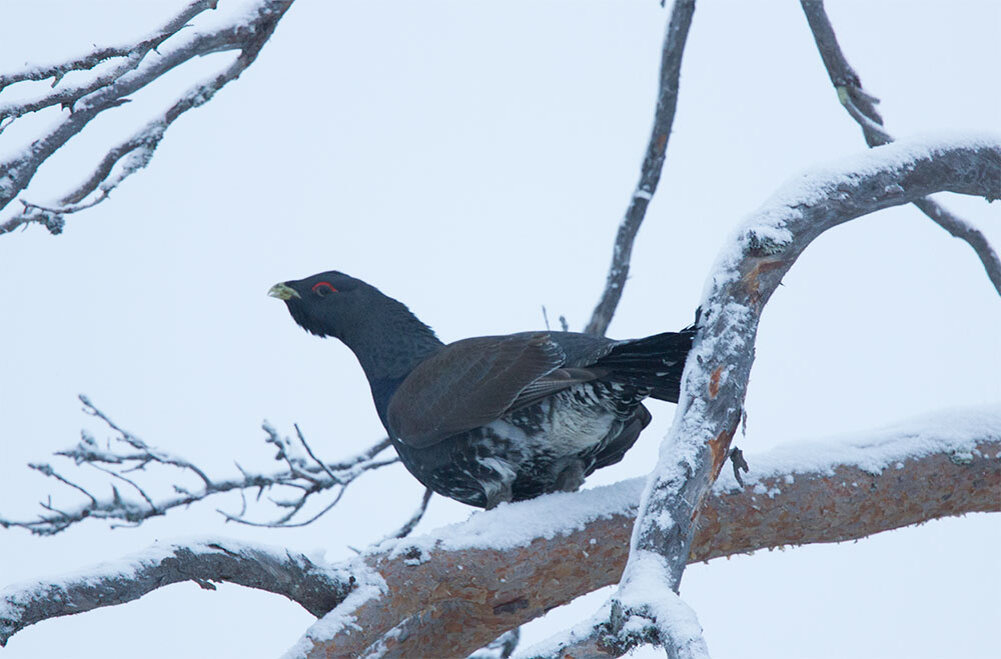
[268,271,695,508]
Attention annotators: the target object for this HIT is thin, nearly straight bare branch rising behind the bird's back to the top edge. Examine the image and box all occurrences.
[584,0,695,336]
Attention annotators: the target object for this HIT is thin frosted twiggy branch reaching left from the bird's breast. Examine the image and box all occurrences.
[0,396,398,537]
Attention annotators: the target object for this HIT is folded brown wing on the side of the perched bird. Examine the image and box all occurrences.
[386,333,570,449]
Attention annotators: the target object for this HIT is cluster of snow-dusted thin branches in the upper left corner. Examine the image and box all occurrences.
[0,0,293,234]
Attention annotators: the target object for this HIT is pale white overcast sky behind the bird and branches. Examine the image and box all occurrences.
[0,0,1001,659]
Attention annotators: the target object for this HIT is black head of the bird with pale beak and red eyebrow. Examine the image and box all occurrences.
[267,270,376,340]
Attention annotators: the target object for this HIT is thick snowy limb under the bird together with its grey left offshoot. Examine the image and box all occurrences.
[0,407,1001,657]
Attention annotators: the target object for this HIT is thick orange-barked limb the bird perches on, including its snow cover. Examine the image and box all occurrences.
[290,408,1001,657]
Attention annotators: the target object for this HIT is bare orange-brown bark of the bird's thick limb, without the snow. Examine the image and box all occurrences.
[304,434,1001,657]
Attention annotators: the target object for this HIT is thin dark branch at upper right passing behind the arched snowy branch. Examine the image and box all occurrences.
[800,0,1001,294]
